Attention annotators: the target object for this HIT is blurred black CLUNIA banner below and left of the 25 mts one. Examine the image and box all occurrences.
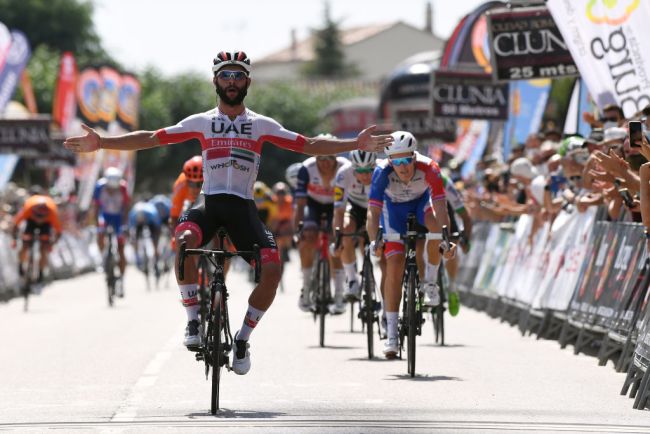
[432,70,509,120]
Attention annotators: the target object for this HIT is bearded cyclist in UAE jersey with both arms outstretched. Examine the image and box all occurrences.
[65,51,392,375]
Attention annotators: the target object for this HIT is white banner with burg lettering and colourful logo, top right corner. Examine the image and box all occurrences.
[546,0,650,117]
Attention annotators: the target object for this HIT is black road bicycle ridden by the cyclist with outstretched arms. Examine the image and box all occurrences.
[178,229,262,414]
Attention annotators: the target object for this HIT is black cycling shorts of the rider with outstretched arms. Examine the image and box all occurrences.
[176,194,280,263]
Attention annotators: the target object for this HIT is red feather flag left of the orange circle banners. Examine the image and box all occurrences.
[52,51,77,133]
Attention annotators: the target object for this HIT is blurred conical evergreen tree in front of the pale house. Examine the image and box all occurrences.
[304,2,357,79]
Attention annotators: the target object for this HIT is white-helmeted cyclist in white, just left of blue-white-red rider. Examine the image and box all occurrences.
[334,150,377,300]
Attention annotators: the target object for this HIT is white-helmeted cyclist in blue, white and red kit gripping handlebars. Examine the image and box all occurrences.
[366,131,455,358]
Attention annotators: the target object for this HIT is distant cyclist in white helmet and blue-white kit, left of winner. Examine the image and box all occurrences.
[93,167,130,284]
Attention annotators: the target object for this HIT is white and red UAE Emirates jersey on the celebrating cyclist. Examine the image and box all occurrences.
[156,107,305,199]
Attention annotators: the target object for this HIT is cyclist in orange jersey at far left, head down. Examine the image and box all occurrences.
[12,194,61,283]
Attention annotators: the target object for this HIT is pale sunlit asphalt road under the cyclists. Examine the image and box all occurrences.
[0,256,650,433]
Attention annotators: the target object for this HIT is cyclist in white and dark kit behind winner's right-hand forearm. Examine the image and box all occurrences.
[294,144,350,314]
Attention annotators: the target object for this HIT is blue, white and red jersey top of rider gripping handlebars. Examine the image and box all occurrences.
[368,152,445,208]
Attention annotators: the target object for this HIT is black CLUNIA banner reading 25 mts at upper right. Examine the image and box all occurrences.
[486,6,578,81]
